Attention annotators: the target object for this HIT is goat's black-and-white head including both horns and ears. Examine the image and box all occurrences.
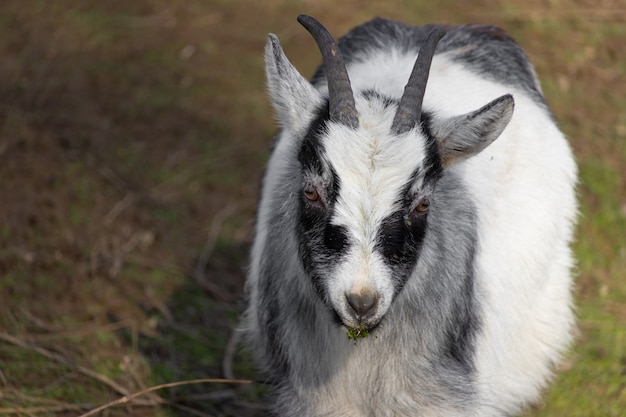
[266,16,513,329]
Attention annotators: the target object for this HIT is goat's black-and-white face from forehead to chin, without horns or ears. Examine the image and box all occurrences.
[297,93,442,329]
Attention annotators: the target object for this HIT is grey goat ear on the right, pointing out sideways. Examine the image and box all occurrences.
[431,94,515,168]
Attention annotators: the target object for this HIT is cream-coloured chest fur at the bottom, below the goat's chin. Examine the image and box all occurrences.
[300,339,471,417]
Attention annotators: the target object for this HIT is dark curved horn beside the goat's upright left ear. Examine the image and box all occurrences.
[298,15,359,128]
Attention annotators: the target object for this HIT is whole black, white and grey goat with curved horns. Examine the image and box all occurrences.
[244,16,577,417]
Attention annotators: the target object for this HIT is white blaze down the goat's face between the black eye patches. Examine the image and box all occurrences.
[324,102,432,327]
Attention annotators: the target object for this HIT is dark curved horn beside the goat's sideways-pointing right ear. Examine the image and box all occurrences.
[391,26,446,135]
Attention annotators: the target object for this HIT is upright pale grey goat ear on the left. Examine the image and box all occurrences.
[265,34,322,132]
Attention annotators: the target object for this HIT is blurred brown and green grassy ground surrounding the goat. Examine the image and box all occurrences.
[0,0,626,417]
